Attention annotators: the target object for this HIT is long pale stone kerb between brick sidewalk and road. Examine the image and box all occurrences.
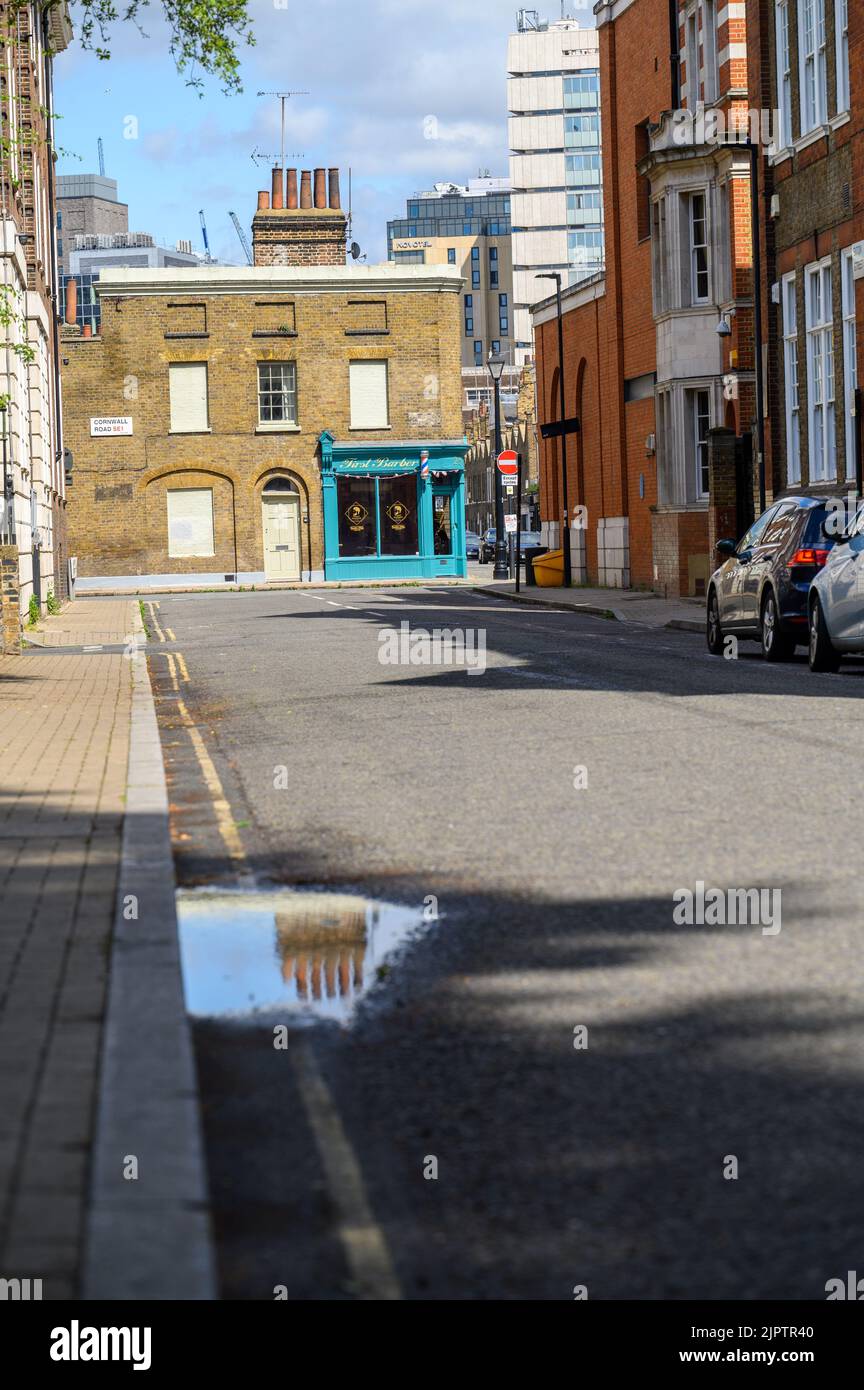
[83,612,217,1301]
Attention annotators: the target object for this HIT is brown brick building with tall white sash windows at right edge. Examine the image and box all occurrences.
[746,0,864,495]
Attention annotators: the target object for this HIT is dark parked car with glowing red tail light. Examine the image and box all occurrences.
[707,495,833,662]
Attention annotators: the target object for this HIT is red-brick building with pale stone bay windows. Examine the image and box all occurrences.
[533,0,756,595]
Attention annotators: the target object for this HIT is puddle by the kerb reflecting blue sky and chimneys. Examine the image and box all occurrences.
[176,888,425,1023]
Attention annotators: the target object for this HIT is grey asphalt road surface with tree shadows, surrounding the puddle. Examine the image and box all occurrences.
[150,589,864,1300]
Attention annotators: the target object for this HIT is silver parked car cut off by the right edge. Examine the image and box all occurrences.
[808,509,864,671]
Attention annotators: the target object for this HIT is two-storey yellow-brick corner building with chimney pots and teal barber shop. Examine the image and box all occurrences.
[64,170,465,587]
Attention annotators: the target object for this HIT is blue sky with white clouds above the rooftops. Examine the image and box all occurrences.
[56,0,593,264]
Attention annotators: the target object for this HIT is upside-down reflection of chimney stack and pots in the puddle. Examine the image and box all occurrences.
[275,897,367,1001]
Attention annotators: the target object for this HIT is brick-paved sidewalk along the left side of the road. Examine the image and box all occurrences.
[0,599,136,1298]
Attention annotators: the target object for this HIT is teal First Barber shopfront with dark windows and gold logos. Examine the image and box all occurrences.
[321,431,468,581]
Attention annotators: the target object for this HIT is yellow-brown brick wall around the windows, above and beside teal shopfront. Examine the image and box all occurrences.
[64,272,463,578]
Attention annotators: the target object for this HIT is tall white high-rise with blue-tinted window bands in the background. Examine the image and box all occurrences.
[507,10,604,364]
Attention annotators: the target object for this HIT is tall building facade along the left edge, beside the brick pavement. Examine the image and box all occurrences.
[0,4,71,648]
